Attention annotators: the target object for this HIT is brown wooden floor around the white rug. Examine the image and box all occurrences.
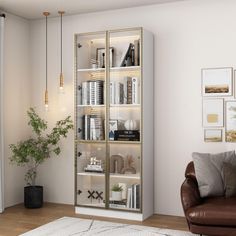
[0,203,188,236]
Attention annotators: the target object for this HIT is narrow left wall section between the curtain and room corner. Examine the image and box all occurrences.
[4,14,30,207]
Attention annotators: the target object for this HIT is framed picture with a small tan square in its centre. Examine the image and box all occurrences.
[202,98,224,127]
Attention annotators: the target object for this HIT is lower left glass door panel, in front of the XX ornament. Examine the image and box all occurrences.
[76,143,106,207]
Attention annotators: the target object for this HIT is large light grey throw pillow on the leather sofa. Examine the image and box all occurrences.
[192,151,236,197]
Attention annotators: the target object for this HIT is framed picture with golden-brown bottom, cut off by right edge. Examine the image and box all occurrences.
[225,101,236,142]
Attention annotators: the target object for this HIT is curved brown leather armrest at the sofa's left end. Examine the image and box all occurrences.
[180,178,202,213]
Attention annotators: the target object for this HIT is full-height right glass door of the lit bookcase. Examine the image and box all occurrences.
[107,29,142,211]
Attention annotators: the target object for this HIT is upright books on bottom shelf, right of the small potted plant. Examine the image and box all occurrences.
[126,184,141,209]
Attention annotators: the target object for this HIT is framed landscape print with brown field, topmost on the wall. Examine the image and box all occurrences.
[202,67,233,97]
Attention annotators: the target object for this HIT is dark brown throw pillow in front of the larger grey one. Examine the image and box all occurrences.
[223,162,236,198]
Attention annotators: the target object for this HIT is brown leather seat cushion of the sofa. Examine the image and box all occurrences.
[186,197,236,227]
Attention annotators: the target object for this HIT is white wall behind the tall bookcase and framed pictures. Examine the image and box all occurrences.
[30,0,236,215]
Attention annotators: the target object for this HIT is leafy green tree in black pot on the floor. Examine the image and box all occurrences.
[10,108,73,208]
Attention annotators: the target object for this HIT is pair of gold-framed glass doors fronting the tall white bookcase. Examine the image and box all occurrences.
[75,29,142,212]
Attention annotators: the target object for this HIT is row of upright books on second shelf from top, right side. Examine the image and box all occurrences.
[110,76,140,104]
